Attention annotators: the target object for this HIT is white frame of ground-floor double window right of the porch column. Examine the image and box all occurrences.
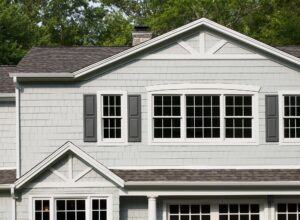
[163,198,268,220]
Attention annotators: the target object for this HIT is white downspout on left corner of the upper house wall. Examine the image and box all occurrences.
[13,77,21,179]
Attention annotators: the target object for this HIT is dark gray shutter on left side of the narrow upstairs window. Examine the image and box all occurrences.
[83,94,97,142]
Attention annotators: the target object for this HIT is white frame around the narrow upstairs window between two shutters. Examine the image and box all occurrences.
[97,91,128,145]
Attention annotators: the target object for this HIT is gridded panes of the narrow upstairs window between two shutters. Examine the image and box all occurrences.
[102,95,122,139]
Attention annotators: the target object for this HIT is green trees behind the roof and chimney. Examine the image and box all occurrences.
[0,0,300,64]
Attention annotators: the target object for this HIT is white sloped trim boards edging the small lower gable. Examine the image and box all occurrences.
[15,142,124,189]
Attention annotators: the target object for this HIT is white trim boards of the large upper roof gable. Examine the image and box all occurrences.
[10,18,300,79]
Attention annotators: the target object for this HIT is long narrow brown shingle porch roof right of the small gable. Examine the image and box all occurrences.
[111,169,300,182]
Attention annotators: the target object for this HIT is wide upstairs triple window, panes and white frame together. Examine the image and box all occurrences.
[148,83,258,144]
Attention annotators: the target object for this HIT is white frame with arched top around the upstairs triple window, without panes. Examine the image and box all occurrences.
[147,84,260,145]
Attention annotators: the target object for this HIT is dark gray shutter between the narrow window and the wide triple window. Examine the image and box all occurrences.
[128,95,142,142]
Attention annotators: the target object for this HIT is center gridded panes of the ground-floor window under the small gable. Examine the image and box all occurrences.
[56,199,86,220]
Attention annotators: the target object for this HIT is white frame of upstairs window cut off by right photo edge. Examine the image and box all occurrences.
[278,90,300,145]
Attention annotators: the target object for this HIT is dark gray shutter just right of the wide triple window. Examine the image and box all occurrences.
[266,95,279,142]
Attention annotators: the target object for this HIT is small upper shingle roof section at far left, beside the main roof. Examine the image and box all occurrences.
[0,65,16,93]
